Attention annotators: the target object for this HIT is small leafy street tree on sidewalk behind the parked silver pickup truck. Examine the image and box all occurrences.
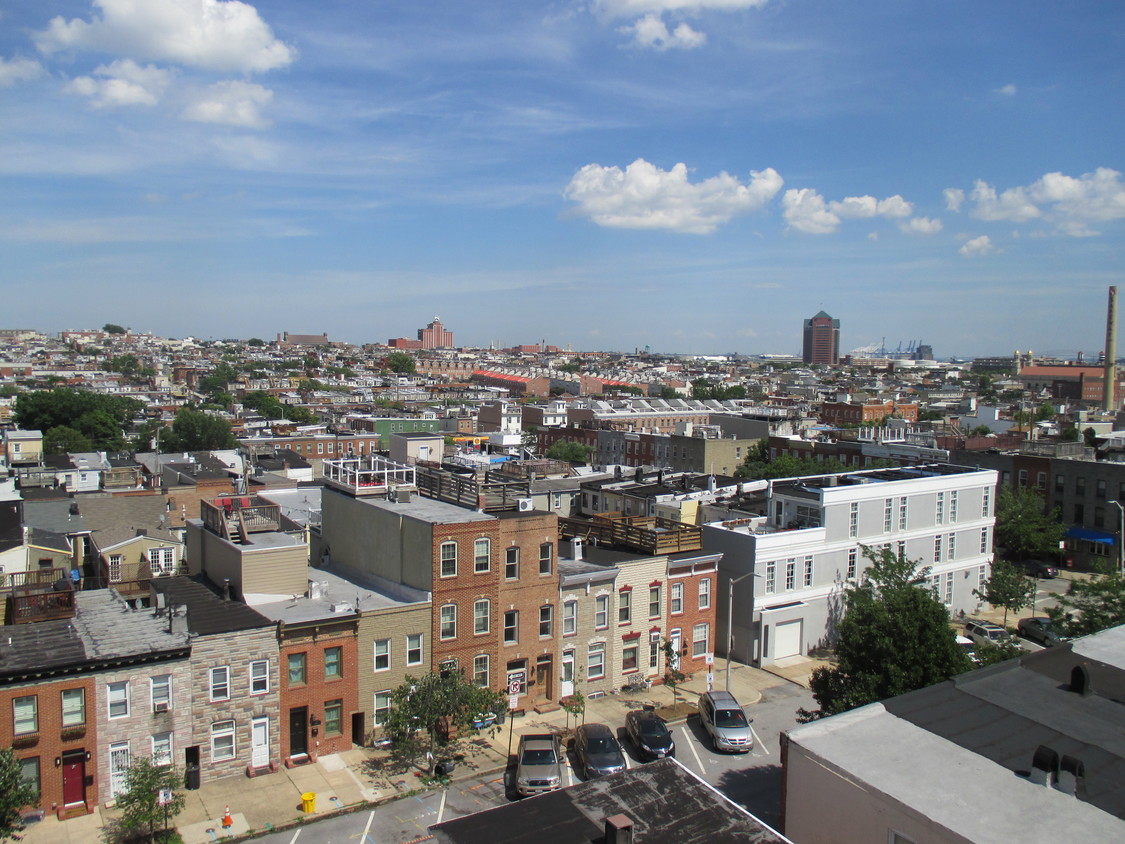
[386,668,507,758]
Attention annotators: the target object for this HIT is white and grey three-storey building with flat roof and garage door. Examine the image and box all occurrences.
[703,464,997,665]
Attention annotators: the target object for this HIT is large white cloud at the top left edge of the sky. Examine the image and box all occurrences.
[36,0,296,72]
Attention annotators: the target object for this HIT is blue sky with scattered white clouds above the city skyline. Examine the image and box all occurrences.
[0,0,1125,358]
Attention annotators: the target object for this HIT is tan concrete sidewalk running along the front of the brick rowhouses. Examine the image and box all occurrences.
[17,659,784,844]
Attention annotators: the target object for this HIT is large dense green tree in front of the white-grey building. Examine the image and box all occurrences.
[798,546,971,720]
